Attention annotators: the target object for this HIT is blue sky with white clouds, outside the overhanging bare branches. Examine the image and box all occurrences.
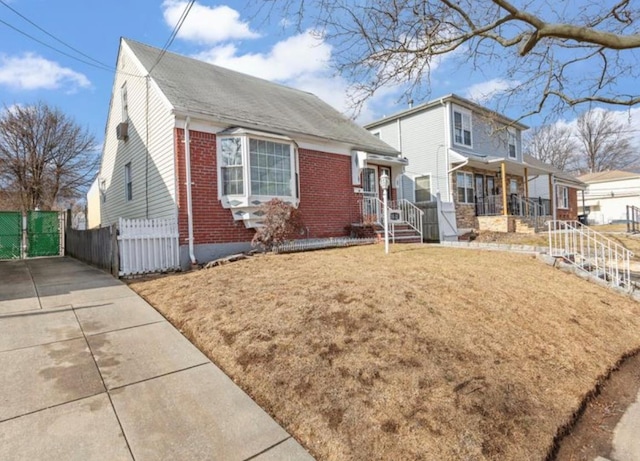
[0,0,640,150]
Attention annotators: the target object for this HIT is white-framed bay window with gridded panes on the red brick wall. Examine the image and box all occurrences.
[218,133,296,197]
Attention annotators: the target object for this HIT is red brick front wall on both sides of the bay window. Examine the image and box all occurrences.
[175,129,359,244]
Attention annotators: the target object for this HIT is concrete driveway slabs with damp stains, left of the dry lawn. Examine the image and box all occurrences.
[0,258,313,461]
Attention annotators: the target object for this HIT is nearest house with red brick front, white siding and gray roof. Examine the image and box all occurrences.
[98,39,407,265]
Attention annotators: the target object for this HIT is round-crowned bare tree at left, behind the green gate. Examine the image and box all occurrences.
[0,103,98,210]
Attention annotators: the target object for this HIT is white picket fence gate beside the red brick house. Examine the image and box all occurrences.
[118,218,180,276]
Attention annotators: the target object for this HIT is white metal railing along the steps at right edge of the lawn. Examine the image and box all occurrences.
[548,221,633,291]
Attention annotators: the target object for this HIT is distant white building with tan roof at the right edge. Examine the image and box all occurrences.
[578,170,640,224]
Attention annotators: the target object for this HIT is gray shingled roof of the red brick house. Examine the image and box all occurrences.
[123,39,398,156]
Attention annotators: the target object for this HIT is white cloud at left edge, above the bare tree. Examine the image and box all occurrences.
[0,53,91,91]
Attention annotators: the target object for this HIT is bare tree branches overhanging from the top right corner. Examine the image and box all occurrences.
[256,0,640,117]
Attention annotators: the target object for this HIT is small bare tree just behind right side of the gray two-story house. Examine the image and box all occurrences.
[524,123,579,172]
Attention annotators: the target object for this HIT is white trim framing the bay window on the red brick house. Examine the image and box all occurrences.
[216,131,299,202]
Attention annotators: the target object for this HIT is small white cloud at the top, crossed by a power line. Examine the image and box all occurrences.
[162,0,259,45]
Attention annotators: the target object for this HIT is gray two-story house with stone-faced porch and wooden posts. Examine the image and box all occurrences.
[365,94,577,239]
